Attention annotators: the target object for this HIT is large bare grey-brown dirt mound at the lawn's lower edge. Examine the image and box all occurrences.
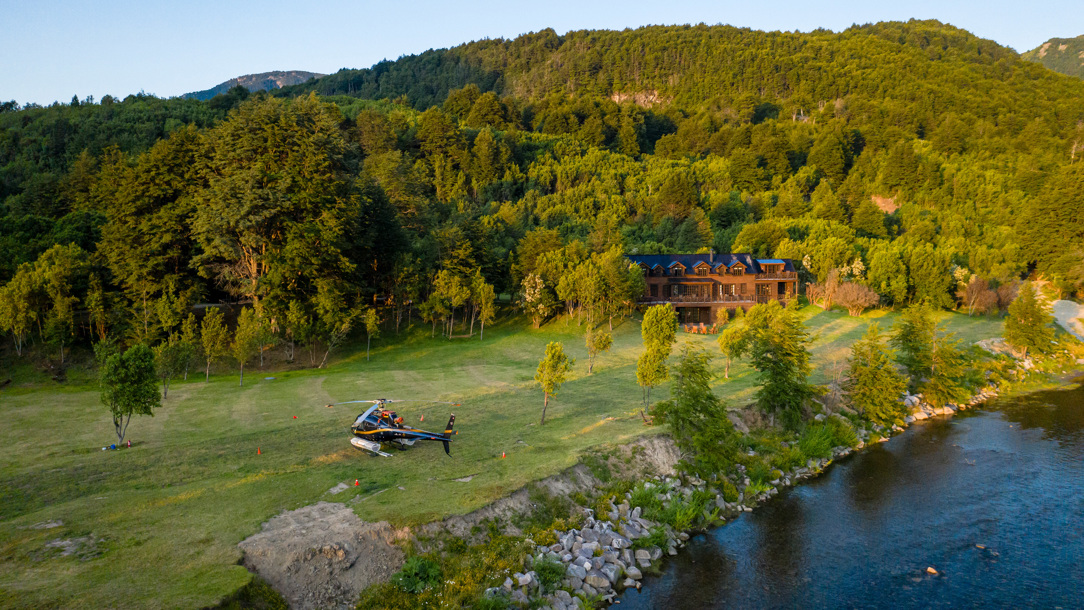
[238,502,403,609]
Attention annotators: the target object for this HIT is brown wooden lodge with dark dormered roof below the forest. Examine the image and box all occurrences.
[625,252,798,324]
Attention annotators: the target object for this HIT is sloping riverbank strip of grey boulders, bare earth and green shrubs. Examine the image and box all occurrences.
[358,335,1084,610]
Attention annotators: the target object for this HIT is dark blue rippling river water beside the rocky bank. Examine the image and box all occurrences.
[620,388,1084,609]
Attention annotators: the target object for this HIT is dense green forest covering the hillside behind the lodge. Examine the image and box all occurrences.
[0,22,1084,363]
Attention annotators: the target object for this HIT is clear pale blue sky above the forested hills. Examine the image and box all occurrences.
[0,0,1084,105]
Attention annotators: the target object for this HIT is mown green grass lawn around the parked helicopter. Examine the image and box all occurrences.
[0,308,1002,608]
